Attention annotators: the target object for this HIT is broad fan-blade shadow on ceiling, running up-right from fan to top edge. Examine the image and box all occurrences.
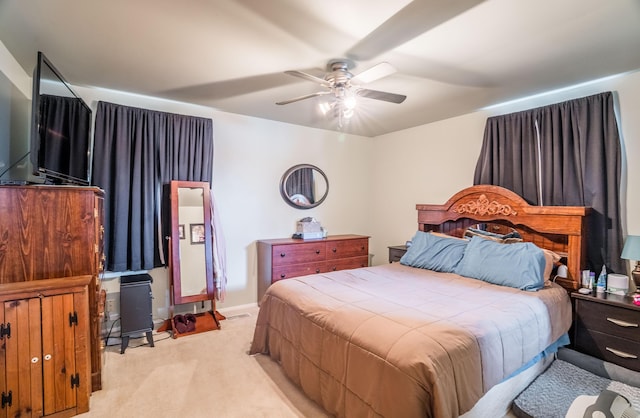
[347,0,484,61]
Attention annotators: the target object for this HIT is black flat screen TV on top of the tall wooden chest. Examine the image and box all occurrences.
[31,52,93,185]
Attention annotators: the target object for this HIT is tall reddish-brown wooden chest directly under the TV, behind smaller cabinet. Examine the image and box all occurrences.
[0,185,104,396]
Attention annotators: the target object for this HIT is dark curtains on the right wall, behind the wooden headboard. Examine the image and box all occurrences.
[474,92,626,274]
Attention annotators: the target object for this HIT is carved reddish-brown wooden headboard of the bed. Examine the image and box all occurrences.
[416,185,591,291]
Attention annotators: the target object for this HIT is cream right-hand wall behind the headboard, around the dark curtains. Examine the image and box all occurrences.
[371,72,640,278]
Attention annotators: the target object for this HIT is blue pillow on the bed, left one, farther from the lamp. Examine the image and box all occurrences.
[400,231,468,273]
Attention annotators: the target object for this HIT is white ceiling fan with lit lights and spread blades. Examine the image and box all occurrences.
[276,58,407,108]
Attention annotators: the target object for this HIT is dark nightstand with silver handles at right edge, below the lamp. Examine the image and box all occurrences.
[571,293,640,371]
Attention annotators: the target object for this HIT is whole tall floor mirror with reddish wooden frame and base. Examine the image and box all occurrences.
[169,180,220,338]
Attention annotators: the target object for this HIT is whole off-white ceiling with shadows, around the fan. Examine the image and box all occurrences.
[0,0,640,136]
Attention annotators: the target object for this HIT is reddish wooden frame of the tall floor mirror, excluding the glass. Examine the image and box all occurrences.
[170,180,215,305]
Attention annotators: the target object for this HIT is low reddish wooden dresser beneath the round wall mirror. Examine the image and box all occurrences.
[258,235,369,302]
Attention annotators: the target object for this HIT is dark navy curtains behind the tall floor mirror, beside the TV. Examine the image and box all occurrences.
[93,102,213,271]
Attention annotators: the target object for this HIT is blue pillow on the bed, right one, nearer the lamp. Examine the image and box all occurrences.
[455,236,545,290]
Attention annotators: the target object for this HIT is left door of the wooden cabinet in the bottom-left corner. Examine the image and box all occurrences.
[0,299,43,417]
